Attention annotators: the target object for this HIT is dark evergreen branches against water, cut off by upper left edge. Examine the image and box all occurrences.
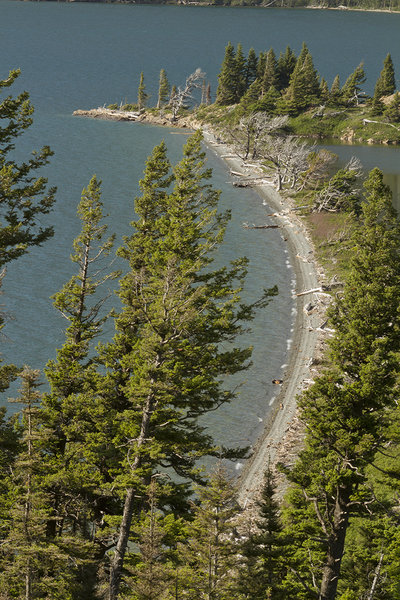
[0,70,56,268]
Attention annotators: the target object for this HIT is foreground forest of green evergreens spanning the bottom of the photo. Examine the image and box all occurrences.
[0,48,400,600]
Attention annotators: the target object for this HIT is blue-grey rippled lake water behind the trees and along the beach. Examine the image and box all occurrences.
[0,0,400,450]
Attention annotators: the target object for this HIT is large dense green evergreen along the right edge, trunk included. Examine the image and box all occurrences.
[284,169,400,600]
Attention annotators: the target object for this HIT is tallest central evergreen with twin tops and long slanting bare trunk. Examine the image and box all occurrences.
[103,134,276,600]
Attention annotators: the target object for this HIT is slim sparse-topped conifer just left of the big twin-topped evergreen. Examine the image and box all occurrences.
[42,176,119,560]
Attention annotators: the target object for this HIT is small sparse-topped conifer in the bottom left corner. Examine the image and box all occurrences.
[0,367,90,600]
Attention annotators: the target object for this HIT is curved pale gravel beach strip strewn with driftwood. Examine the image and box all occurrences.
[203,128,329,509]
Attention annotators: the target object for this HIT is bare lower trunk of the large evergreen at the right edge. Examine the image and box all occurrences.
[319,489,349,600]
